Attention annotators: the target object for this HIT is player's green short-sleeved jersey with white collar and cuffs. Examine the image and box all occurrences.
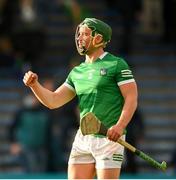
[65,52,134,128]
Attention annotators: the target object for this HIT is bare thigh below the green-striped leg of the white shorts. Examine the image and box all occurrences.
[97,168,120,179]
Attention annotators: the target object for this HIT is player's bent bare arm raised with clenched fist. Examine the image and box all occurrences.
[23,71,75,109]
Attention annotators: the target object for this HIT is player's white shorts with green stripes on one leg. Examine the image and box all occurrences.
[68,130,125,169]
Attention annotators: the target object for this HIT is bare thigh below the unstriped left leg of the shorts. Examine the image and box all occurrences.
[68,163,95,179]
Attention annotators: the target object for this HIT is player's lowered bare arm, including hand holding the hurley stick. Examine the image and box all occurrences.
[107,82,138,141]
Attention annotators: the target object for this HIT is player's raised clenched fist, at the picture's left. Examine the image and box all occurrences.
[23,71,38,87]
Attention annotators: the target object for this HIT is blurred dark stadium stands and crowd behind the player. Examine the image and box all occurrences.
[0,0,176,178]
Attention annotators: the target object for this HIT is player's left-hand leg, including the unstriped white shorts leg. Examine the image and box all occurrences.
[68,130,96,179]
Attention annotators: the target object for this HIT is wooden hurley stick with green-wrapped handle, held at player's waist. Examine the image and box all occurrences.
[80,112,167,171]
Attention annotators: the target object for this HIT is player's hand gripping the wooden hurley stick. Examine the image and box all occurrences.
[107,124,124,142]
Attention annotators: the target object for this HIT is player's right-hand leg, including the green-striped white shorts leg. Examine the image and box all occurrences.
[93,135,125,179]
